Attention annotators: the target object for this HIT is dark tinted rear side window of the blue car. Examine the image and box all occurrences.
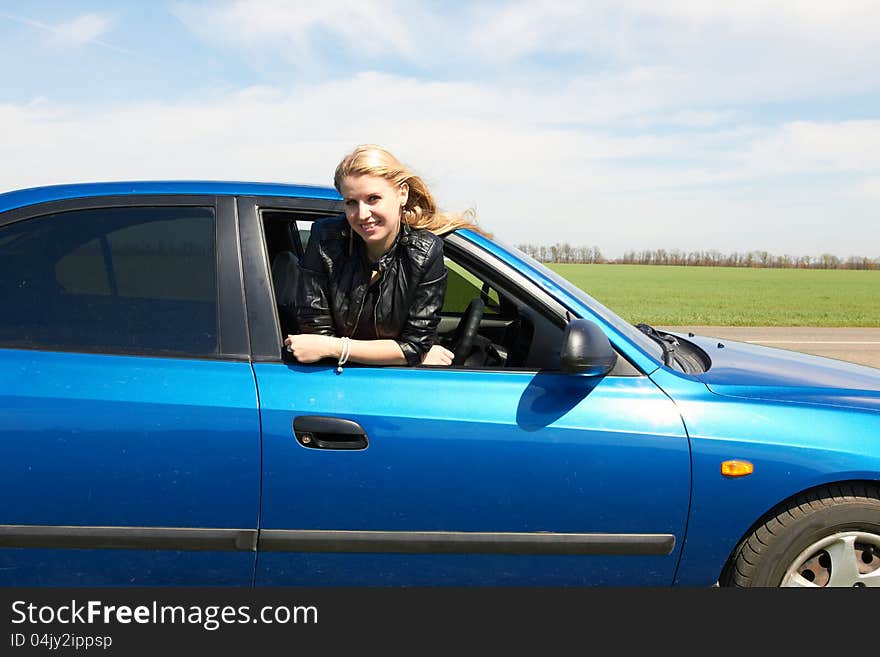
[0,206,218,355]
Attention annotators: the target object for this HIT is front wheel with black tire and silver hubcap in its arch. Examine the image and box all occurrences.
[719,484,880,587]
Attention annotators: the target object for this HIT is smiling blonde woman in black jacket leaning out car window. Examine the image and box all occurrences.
[284,144,482,372]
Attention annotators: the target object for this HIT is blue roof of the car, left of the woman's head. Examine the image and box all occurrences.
[0,180,341,212]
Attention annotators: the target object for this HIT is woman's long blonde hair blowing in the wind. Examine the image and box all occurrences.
[333,144,492,237]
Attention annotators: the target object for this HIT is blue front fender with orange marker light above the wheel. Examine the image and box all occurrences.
[651,368,880,586]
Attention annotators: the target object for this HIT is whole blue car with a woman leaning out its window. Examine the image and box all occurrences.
[0,181,880,587]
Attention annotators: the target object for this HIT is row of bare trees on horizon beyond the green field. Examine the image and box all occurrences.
[516,242,880,270]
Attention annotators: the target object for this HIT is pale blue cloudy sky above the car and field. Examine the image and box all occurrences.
[0,0,880,258]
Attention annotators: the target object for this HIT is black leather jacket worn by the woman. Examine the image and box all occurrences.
[296,215,447,365]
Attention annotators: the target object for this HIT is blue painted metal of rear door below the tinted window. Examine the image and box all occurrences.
[0,349,260,585]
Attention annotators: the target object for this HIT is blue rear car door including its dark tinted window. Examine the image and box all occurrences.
[0,196,260,585]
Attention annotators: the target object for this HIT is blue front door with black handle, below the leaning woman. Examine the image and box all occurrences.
[241,199,690,585]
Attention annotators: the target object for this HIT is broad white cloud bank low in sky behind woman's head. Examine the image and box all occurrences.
[0,74,880,257]
